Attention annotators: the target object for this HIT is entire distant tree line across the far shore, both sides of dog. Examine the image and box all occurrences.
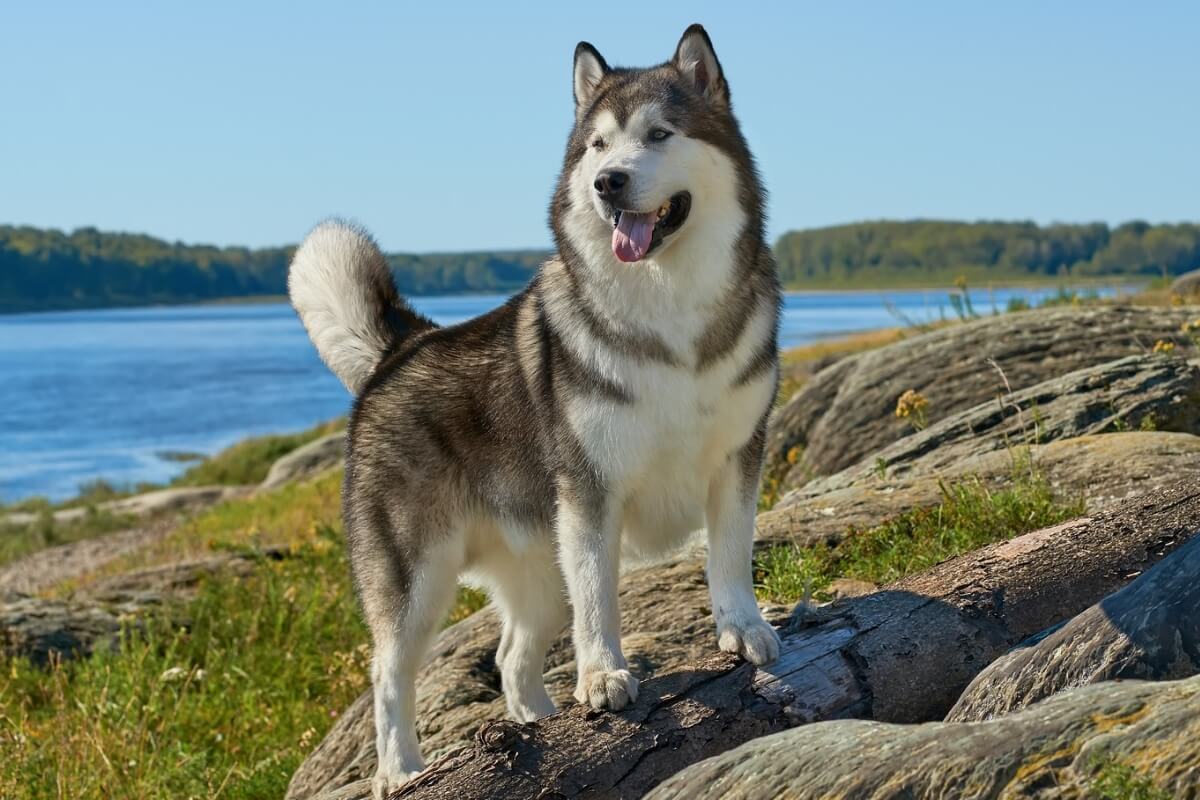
[0,221,1200,312]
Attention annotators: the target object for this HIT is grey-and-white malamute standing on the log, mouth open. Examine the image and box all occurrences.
[288,25,780,798]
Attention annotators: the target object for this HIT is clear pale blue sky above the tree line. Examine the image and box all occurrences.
[0,0,1200,252]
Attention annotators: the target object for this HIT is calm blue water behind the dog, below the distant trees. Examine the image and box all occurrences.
[0,289,1128,501]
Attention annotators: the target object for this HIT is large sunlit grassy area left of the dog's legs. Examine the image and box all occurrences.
[0,475,486,799]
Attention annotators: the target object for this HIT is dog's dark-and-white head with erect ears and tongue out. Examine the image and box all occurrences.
[552,25,761,268]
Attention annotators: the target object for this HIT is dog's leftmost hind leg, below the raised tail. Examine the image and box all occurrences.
[353,520,463,799]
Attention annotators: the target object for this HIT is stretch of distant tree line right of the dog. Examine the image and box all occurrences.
[775,221,1200,287]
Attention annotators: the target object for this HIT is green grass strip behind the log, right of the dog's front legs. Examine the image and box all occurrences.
[755,469,1084,603]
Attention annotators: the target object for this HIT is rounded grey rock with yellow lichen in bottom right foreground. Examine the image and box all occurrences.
[646,678,1200,800]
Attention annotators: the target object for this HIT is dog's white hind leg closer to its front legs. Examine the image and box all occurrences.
[488,547,568,722]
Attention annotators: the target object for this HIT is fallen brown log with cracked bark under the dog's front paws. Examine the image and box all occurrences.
[384,486,1200,800]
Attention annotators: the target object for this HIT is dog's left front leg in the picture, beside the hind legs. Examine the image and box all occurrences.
[556,485,637,711]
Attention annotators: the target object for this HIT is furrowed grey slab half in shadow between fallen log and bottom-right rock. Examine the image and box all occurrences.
[946,537,1200,722]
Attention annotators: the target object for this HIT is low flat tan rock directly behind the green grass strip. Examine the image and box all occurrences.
[757,432,1200,547]
